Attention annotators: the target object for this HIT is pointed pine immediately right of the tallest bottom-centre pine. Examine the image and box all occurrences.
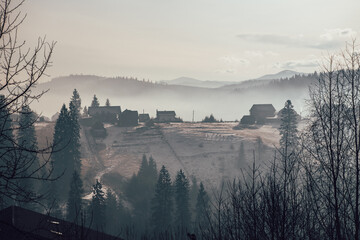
[175,170,191,232]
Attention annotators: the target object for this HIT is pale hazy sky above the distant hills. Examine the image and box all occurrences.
[20,0,360,80]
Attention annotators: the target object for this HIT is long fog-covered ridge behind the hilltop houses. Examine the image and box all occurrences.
[33,71,315,121]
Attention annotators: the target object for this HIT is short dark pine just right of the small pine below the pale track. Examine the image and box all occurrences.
[105,189,120,235]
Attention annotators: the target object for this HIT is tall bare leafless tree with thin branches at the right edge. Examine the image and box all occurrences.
[303,41,360,239]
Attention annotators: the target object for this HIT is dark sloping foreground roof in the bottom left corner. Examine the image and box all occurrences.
[0,206,121,240]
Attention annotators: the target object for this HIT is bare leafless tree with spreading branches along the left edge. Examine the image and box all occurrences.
[0,0,55,208]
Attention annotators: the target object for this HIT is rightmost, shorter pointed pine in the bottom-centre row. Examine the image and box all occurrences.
[195,182,210,232]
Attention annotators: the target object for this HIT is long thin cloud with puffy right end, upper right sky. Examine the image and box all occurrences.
[237,28,357,49]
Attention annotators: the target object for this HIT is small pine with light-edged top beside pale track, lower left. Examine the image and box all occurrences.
[90,179,106,231]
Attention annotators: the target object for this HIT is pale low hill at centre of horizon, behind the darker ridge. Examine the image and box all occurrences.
[162,77,238,88]
